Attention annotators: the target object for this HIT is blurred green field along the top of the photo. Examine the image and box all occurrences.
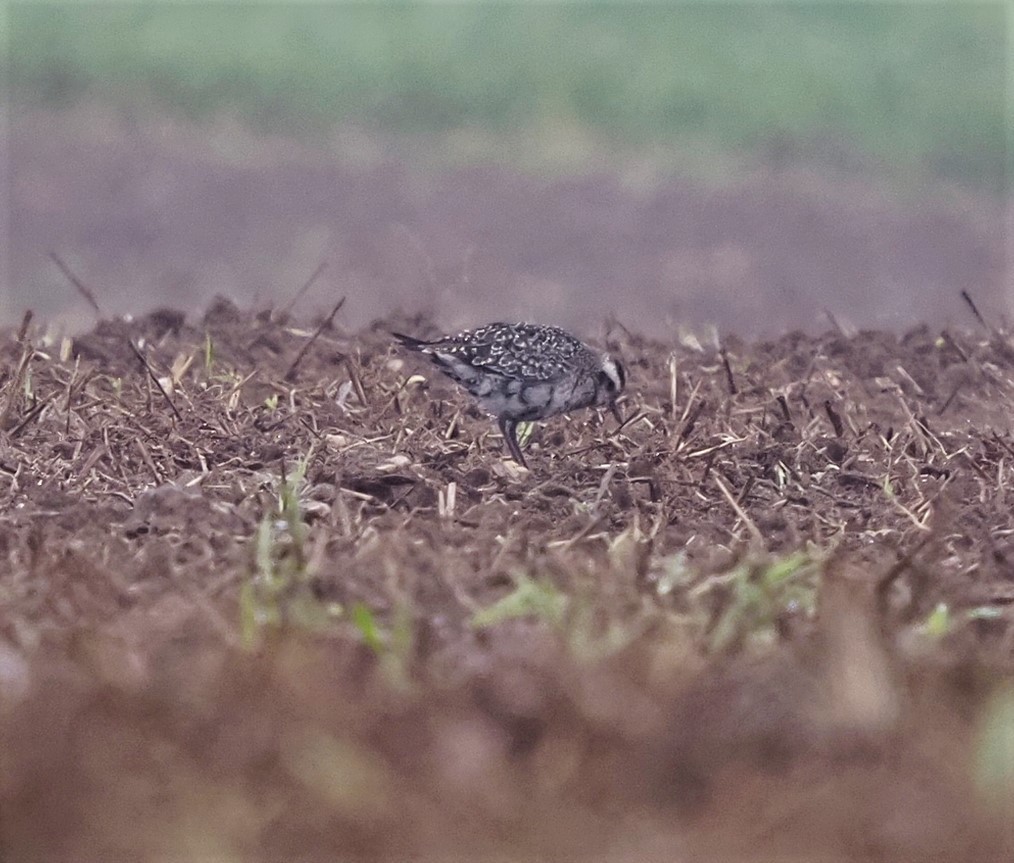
[6,2,1008,189]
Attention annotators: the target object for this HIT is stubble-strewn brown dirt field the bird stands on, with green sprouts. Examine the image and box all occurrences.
[0,301,1014,863]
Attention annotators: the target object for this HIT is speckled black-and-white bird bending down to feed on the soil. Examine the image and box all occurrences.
[391,321,627,468]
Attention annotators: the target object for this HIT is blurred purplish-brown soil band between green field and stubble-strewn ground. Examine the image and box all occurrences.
[7,104,1014,338]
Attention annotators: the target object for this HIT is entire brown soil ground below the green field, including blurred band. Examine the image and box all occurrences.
[0,115,1014,861]
